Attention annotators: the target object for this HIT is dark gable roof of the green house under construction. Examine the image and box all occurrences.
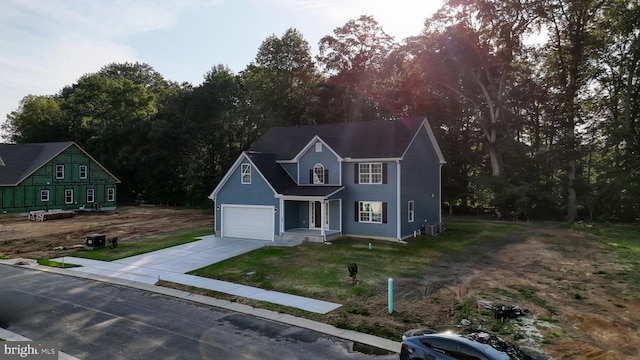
[0,141,120,186]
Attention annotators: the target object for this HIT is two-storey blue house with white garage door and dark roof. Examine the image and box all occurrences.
[209,119,445,241]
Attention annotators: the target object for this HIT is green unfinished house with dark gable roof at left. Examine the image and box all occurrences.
[0,141,120,214]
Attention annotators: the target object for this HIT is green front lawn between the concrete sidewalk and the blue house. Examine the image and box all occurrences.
[191,218,527,301]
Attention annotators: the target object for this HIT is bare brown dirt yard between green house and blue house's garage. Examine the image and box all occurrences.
[0,206,213,259]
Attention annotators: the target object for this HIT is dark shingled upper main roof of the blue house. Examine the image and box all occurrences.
[249,118,430,160]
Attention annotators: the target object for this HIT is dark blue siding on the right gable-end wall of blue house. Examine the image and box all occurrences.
[400,127,441,237]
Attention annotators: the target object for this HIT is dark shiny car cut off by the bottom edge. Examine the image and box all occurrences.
[400,326,532,360]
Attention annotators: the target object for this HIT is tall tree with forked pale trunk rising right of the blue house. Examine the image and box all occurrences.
[425,0,537,177]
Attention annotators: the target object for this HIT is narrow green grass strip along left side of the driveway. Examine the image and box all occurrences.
[73,229,211,261]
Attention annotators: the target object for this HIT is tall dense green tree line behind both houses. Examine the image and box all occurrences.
[2,0,640,222]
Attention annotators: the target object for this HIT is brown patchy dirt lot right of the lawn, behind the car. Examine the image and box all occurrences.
[344,226,640,360]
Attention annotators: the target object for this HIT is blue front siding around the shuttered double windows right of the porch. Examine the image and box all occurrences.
[341,162,398,239]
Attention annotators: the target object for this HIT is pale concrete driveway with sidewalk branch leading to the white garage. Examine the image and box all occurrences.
[53,236,341,314]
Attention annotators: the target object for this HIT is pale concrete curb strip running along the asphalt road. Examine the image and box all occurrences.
[0,259,400,353]
